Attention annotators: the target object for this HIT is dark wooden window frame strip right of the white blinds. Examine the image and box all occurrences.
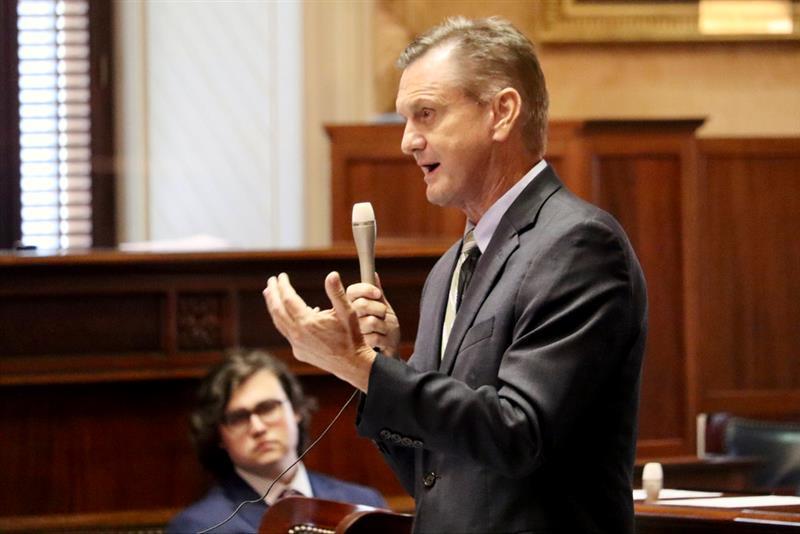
[89,0,117,247]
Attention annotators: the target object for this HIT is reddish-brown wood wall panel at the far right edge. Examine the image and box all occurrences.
[695,139,800,415]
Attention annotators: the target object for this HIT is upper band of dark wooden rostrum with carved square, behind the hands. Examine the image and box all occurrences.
[0,242,446,388]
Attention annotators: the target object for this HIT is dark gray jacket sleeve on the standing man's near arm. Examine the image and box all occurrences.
[359,220,637,484]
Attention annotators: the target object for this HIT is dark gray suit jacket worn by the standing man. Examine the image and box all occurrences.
[357,167,647,534]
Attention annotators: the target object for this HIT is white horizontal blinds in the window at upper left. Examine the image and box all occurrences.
[17,0,92,249]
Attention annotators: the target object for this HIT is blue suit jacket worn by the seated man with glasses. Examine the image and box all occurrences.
[167,471,387,534]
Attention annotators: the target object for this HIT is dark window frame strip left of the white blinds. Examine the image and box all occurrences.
[0,0,20,249]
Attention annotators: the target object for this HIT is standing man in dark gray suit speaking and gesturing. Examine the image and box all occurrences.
[264,18,647,534]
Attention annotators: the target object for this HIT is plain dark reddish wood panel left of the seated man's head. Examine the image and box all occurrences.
[0,381,204,515]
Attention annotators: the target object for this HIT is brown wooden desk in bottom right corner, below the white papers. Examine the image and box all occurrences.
[635,502,800,534]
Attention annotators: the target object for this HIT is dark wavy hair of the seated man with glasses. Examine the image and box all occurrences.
[189,349,316,479]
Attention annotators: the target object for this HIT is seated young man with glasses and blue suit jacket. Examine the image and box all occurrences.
[167,351,386,533]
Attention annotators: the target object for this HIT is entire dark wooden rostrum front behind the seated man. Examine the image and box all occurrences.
[0,247,444,516]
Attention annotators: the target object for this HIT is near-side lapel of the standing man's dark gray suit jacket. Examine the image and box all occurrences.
[437,165,562,374]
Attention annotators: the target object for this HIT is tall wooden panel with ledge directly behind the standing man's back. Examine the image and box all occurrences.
[584,121,698,457]
